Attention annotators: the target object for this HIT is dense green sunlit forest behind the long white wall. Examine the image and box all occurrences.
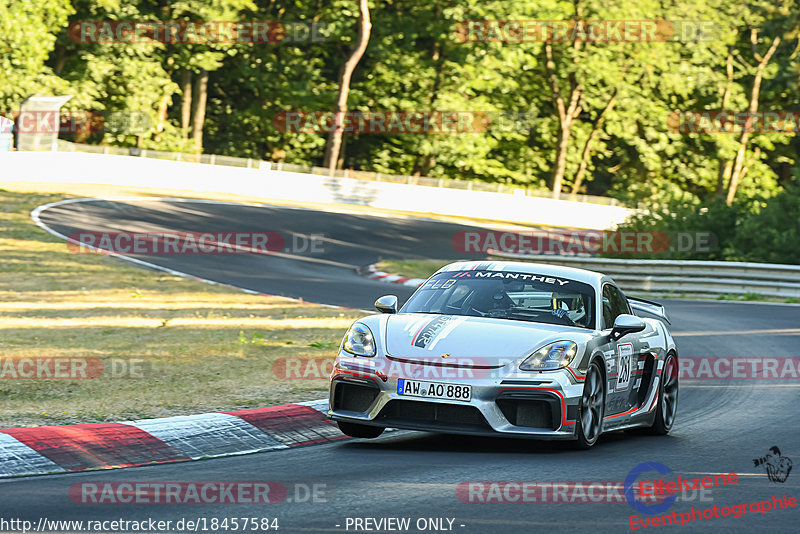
[0,0,800,211]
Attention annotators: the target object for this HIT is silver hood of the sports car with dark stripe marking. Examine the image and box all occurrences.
[384,313,588,363]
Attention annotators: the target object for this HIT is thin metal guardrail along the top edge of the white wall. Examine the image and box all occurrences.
[58,139,622,206]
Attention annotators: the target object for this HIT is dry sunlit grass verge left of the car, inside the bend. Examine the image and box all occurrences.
[0,186,361,427]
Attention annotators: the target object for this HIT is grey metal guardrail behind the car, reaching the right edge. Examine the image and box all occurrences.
[489,251,800,298]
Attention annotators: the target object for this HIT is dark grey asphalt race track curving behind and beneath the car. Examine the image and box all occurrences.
[7,201,800,534]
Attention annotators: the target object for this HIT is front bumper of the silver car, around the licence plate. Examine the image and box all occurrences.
[328,355,583,439]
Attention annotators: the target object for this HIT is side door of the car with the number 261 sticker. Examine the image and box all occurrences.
[601,282,642,420]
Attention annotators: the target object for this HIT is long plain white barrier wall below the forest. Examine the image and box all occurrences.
[0,152,631,230]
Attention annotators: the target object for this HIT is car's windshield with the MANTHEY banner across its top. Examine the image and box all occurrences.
[400,271,595,328]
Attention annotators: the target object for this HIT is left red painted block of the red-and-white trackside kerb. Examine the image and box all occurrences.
[2,423,190,471]
